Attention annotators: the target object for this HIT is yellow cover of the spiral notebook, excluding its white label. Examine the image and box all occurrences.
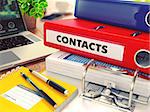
[0,67,78,112]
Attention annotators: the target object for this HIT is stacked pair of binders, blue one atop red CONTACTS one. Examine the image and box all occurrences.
[44,0,150,77]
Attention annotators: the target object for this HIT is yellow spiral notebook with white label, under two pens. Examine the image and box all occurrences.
[0,67,78,112]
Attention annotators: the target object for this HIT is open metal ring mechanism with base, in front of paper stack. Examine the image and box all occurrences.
[80,59,149,112]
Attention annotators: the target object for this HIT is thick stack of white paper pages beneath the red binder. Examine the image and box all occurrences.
[46,51,150,97]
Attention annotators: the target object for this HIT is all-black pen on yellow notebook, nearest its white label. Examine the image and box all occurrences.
[21,73,57,108]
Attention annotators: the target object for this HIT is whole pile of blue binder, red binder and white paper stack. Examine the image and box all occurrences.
[44,0,150,107]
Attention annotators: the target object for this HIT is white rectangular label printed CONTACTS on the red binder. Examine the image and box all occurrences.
[46,30,124,61]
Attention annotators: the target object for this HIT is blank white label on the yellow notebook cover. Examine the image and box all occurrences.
[2,86,41,110]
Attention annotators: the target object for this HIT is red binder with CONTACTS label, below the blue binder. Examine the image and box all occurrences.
[44,19,150,77]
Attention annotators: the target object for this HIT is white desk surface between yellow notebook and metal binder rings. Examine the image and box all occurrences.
[44,72,150,112]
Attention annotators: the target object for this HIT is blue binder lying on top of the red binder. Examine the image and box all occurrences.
[75,0,150,32]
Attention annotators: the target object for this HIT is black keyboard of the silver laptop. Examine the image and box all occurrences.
[0,36,33,51]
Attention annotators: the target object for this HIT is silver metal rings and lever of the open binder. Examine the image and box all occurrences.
[81,59,146,111]
